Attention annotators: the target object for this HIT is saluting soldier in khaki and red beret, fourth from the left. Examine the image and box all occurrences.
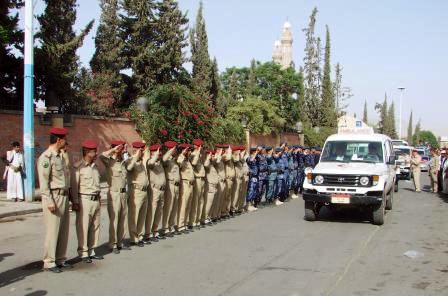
[126,141,149,247]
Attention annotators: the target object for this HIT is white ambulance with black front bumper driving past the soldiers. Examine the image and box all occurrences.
[303,128,398,225]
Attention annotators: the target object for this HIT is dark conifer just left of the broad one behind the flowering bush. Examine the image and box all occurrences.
[120,0,158,95]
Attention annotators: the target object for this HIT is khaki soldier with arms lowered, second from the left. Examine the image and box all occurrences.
[72,140,104,263]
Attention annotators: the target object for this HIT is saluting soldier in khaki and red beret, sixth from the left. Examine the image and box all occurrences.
[161,141,180,237]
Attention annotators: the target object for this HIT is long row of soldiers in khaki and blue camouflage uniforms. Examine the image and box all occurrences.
[38,128,317,273]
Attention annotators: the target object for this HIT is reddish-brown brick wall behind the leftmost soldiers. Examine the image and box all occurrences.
[0,111,140,188]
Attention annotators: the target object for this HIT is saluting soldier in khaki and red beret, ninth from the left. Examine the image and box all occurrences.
[201,150,219,224]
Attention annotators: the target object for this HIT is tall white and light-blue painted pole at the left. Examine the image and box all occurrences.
[23,0,35,201]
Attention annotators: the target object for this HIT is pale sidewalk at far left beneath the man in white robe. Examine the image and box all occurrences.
[0,183,108,219]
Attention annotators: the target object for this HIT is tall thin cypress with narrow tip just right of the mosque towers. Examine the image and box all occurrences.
[303,8,321,127]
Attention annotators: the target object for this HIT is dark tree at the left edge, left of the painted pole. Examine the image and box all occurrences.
[0,0,23,109]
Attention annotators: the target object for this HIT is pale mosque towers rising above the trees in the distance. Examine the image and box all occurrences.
[272,21,294,69]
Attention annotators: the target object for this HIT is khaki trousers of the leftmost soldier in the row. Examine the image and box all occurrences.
[42,191,70,268]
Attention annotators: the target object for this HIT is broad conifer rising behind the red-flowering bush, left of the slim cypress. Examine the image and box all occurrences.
[154,0,188,84]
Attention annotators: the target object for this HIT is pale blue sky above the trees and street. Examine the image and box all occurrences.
[26,0,448,136]
